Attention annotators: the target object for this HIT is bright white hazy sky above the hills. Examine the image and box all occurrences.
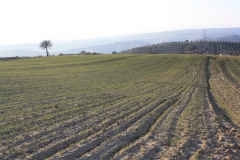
[0,0,240,45]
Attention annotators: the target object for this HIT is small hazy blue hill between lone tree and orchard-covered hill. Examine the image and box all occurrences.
[68,41,150,53]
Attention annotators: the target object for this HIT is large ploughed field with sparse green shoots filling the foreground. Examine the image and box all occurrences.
[0,54,240,160]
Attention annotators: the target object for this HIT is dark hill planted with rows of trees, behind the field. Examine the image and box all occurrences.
[121,41,240,55]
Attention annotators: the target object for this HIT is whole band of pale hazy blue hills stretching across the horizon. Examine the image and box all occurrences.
[0,28,240,57]
